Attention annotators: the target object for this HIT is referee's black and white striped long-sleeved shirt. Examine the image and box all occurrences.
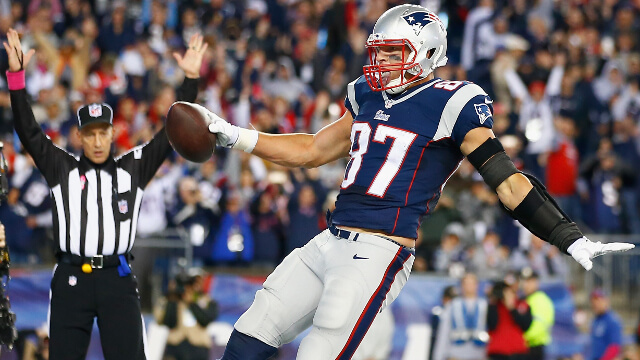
[11,78,197,256]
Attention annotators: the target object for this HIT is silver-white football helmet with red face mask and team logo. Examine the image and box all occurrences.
[363,5,447,94]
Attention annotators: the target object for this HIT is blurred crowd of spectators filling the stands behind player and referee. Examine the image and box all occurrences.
[0,0,640,277]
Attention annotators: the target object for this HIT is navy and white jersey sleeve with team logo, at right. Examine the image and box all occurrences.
[451,84,493,146]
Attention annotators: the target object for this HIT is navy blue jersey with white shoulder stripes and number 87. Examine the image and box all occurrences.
[332,76,493,238]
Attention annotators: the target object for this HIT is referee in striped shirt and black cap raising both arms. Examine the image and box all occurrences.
[3,29,207,360]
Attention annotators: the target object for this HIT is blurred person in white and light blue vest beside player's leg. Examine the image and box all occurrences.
[433,273,489,360]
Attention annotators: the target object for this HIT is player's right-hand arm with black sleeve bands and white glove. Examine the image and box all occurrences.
[460,128,635,270]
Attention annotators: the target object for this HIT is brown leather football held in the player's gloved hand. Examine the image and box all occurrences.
[165,101,216,162]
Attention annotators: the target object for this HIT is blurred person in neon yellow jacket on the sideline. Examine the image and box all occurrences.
[520,268,555,360]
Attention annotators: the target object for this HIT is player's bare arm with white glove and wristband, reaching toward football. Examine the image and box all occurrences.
[207,110,353,168]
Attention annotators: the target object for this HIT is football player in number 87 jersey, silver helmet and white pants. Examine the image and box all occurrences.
[203,5,633,360]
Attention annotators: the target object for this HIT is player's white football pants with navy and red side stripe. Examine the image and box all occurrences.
[235,229,414,360]
